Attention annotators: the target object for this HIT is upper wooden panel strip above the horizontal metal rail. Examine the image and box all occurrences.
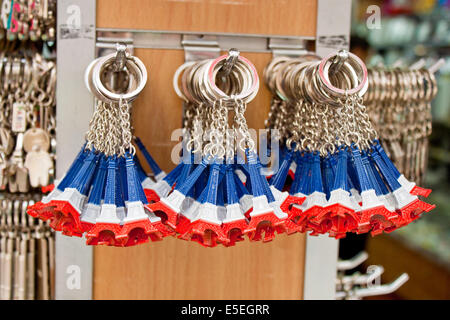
[97,0,317,37]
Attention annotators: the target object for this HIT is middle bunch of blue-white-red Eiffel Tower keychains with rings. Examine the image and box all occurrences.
[147,50,304,247]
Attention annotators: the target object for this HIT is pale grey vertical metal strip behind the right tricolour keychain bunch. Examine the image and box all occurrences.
[303,0,352,300]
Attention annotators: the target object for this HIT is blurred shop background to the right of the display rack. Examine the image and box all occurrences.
[339,0,450,299]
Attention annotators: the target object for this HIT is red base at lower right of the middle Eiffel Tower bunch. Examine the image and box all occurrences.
[244,211,286,242]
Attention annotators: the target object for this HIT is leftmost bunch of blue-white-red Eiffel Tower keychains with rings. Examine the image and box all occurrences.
[28,47,172,246]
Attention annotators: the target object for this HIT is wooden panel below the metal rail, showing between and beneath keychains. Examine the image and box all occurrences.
[94,49,305,299]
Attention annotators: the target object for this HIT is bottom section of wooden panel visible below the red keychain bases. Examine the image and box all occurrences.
[94,234,304,300]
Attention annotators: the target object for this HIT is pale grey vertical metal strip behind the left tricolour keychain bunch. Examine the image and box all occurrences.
[55,0,96,300]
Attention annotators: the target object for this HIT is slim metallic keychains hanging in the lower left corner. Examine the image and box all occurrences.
[0,194,55,300]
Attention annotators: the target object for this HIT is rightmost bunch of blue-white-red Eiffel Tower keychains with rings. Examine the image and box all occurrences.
[265,51,434,238]
